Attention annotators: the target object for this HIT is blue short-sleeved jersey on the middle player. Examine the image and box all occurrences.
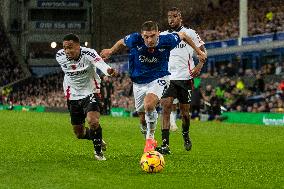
[124,33,181,84]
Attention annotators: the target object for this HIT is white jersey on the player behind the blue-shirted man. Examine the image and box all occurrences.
[161,26,204,80]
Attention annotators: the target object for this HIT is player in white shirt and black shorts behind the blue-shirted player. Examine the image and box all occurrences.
[157,7,207,154]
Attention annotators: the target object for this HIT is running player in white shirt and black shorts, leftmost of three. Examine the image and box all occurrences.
[56,33,117,160]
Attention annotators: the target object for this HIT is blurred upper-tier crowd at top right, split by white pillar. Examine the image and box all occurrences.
[184,0,284,41]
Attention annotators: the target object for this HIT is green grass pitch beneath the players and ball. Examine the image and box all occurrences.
[0,111,284,189]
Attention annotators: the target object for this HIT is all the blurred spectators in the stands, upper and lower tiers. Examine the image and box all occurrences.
[0,0,284,115]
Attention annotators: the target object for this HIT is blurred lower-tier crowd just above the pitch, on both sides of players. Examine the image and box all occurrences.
[0,69,284,115]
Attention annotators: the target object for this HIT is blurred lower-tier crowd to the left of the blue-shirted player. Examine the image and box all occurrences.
[0,73,134,114]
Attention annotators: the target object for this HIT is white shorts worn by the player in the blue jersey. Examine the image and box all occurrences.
[133,76,170,112]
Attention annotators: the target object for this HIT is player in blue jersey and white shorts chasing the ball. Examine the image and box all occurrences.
[100,21,206,152]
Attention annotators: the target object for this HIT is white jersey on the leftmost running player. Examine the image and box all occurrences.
[56,47,108,100]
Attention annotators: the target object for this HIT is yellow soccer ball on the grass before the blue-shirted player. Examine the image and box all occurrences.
[140,151,165,173]
